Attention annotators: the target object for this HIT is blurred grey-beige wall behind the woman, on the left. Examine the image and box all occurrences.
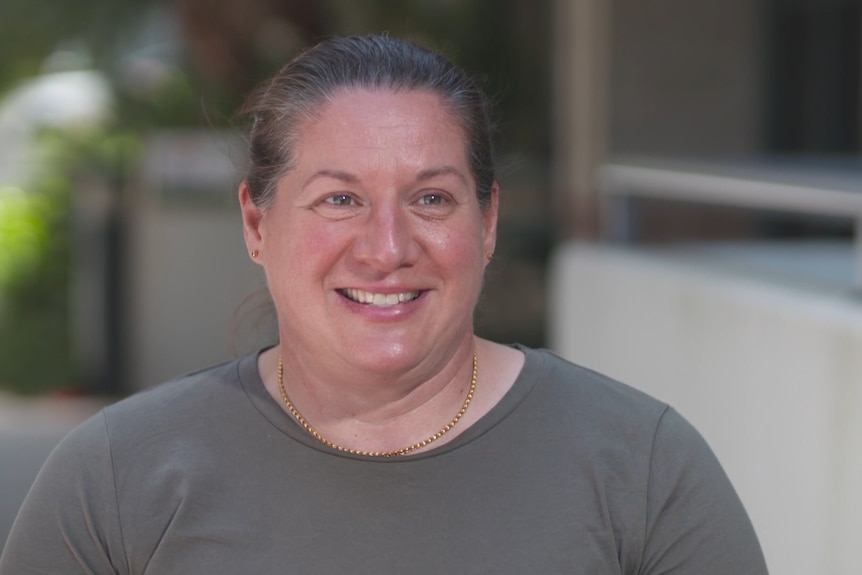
[123,132,274,391]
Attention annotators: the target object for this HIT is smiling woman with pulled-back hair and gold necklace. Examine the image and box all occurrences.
[0,37,766,575]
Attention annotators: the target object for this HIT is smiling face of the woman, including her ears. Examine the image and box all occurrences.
[240,90,498,373]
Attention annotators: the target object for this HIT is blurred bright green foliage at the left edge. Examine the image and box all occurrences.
[0,127,138,394]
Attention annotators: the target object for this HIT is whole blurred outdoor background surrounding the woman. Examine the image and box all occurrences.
[0,0,862,574]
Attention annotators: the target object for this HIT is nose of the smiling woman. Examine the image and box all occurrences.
[353,202,416,272]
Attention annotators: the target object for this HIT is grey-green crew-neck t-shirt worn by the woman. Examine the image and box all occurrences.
[0,348,766,575]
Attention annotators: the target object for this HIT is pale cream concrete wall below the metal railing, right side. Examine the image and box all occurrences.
[549,244,862,575]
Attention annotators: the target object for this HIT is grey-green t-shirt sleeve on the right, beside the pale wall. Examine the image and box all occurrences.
[639,408,767,575]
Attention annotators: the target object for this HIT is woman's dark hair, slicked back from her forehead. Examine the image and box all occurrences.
[241,36,495,209]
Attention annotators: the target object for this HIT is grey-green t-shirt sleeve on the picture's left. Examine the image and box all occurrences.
[0,414,124,575]
